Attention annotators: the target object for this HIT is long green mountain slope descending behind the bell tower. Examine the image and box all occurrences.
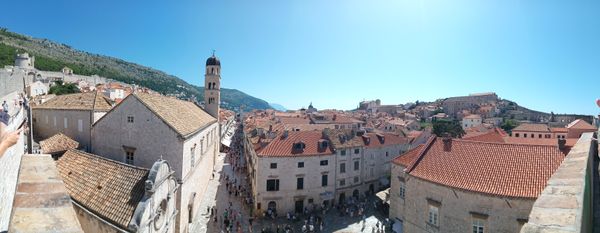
[0,28,271,110]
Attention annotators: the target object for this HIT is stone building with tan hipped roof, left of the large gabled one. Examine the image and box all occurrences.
[32,92,112,151]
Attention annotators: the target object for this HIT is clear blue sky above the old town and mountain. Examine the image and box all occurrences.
[0,0,600,114]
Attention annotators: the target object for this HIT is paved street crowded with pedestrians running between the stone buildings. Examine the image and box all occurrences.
[190,131,390,233]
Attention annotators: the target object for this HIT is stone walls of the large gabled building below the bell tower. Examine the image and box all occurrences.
[92,96,220,232]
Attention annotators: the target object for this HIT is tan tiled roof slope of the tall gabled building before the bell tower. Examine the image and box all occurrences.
[133,93,217,137]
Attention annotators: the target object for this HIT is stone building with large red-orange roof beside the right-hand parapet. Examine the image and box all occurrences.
[390,137,566,233]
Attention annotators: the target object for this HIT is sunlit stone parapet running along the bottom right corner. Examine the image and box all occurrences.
[521,133,598,233]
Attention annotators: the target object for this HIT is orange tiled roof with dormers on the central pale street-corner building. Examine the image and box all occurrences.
[257,131,333,157]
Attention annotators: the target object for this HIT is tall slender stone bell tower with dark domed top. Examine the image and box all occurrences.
[204,50,221,120]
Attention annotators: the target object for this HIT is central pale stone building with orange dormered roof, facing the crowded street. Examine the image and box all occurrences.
[252,131,335,214]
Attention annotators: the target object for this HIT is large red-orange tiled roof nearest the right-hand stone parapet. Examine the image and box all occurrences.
[398,138,565,198]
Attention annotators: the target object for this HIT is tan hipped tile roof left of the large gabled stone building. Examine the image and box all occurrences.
[32,91,112,112]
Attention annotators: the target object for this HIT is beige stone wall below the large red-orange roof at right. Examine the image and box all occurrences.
[390,164,534,233]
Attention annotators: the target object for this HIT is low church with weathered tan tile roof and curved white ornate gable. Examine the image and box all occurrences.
[57,150,179,233]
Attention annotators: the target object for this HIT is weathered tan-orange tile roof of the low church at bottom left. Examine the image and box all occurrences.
[56,150,149,229]
